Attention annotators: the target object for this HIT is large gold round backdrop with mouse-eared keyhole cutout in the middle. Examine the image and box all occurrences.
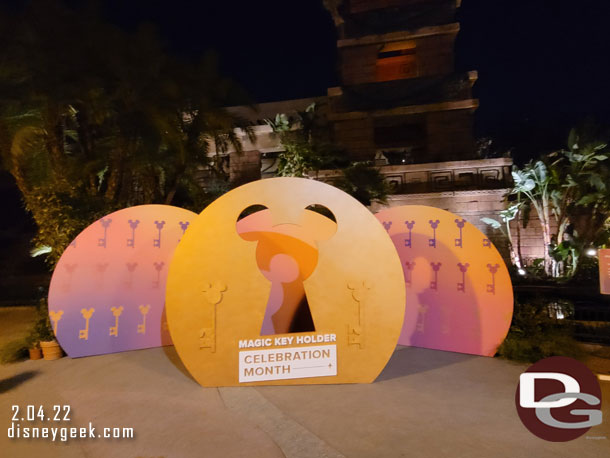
[166,178,405,386]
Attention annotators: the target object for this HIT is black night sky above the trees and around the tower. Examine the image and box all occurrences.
[0,0,610,262]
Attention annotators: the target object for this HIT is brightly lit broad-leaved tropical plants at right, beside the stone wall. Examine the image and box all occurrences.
[494,129,610,277]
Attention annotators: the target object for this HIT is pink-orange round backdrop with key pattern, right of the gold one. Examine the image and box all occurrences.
[376,205,513,356]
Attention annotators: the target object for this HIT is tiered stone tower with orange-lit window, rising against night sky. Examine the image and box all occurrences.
[328,0,478,165]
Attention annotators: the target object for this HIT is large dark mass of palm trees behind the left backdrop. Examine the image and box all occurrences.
[0,0,253,265]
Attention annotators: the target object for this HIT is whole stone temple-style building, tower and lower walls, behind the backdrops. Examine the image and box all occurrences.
[204,0,542,258]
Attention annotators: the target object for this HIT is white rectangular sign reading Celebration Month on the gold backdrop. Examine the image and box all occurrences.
[239,345,337,383]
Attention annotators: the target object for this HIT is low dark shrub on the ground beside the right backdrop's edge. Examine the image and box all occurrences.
[497,296,584,362]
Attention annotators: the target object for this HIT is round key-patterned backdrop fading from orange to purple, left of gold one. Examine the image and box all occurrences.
[49,205,197,357]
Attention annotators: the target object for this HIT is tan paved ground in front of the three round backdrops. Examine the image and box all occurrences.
[0,347,610,458]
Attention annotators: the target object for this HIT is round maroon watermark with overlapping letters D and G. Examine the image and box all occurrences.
[515,356,602,442]
